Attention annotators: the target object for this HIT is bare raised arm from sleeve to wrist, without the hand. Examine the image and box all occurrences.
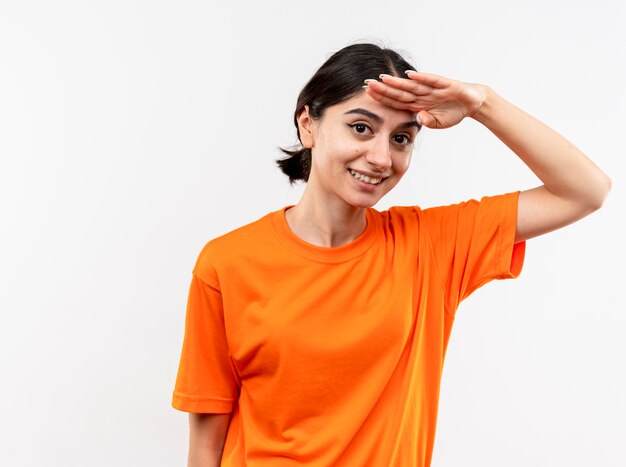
[472,86,611,242]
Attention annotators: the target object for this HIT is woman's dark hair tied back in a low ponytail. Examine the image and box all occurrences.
[276,44,417,184]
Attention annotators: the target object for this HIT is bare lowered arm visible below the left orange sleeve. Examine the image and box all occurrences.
[187,413,230,467]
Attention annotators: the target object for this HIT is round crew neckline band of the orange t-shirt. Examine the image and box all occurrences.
[271,205,377,263]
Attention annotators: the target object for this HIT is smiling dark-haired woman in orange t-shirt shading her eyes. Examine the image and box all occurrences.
[173,44,611,467]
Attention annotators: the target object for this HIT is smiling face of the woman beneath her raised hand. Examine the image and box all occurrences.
[298,92,419,208]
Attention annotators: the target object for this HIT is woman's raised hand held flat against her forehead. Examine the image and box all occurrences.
[365,71,487,128]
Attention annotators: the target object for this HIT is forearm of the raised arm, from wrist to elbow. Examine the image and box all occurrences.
[472,86,611,208]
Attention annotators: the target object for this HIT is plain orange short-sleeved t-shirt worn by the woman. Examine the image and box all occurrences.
[173,192,525,467]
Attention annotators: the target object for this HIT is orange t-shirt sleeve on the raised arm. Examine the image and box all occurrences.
[423,192,526,314]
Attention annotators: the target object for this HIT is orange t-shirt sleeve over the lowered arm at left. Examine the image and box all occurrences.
[172,270,239,413]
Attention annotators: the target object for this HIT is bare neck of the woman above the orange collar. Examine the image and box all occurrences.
[285,186,367,247]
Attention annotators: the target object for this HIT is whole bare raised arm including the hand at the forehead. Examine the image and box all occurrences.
[366,72,611,242]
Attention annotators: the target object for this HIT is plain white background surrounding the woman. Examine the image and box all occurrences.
[0,0,626,467]
